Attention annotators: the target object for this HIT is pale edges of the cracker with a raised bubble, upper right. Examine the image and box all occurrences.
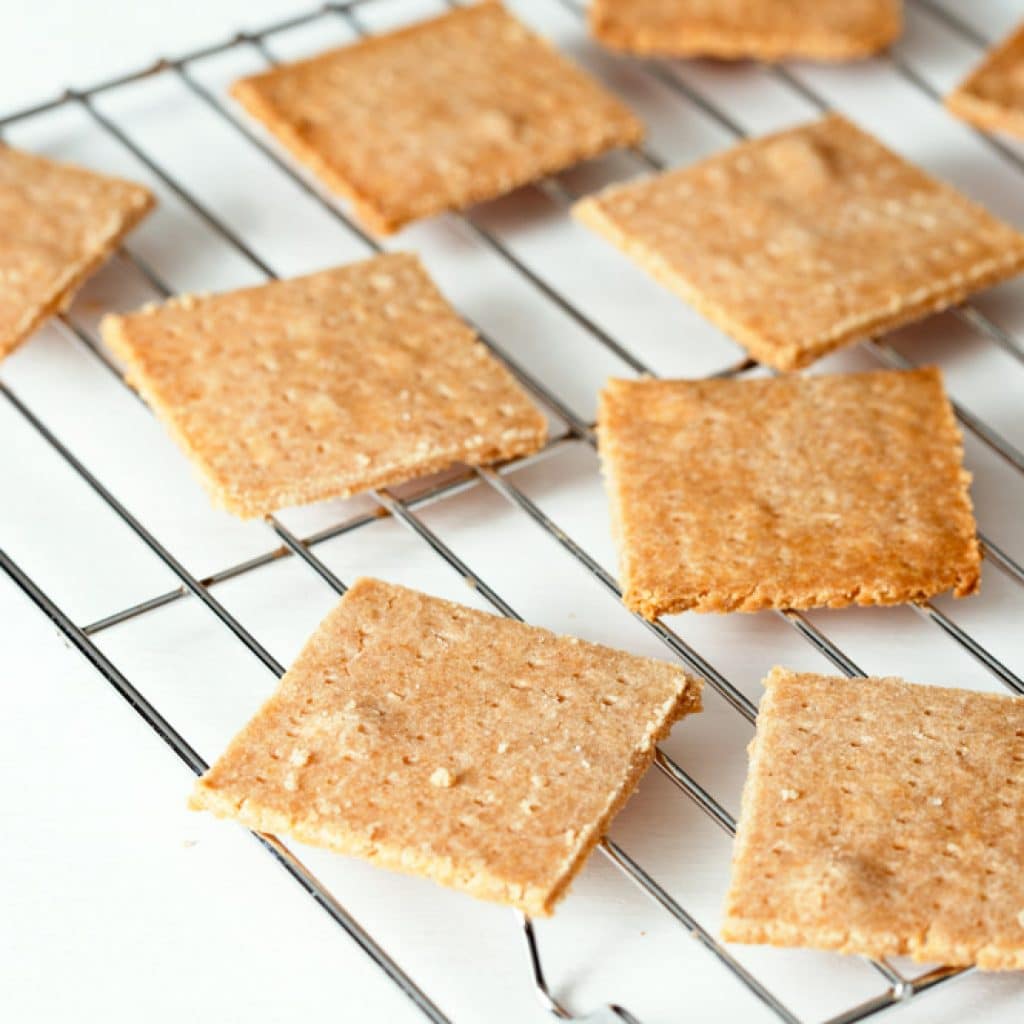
[571,114,1024,371]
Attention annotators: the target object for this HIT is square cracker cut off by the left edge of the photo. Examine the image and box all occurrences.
[0,143,154,358]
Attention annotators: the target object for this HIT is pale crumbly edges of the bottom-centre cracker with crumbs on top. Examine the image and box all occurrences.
[187,577,703,918]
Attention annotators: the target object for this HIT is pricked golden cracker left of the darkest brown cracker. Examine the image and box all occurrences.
[102,253,547,516]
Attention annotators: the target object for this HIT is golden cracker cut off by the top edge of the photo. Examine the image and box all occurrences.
[590,0,903,60]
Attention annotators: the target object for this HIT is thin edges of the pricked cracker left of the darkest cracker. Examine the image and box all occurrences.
[99,262,548,519]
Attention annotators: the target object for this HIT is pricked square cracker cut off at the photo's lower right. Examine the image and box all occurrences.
[722,669,1024,971]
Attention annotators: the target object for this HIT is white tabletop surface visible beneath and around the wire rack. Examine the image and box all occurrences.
[0,0,1024,1024]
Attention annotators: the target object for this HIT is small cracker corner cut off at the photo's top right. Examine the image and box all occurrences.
[946,23,1024,138]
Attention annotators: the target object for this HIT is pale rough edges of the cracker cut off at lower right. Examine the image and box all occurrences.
[719,666,1024,971]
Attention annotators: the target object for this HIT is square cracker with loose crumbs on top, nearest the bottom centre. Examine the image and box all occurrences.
[191,579,700,914]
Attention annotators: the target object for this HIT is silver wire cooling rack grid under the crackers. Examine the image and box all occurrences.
[0,0,1024,1024]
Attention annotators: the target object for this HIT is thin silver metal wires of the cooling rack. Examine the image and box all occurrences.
[0,0,1024,1024]
